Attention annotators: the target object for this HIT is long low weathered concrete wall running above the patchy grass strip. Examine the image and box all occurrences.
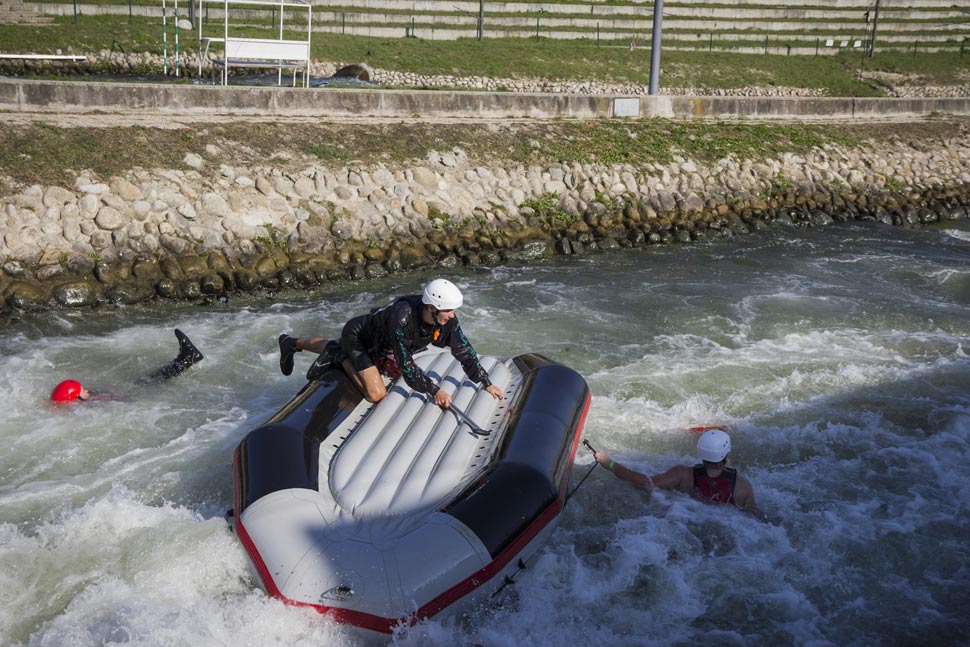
[0,79,970,121]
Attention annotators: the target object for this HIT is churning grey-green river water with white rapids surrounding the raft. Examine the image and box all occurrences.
[0,222,970,647]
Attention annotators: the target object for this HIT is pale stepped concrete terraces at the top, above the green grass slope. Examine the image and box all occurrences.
[17,0,970,53]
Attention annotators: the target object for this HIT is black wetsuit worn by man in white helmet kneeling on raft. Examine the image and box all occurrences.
[341,294,492,395]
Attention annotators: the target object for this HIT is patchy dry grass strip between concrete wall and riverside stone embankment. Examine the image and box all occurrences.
[0,119,970,192]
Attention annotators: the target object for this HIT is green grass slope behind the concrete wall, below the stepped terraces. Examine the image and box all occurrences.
[0,15,970,96]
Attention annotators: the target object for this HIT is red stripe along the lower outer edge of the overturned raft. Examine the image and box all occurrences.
[234,394,592,634]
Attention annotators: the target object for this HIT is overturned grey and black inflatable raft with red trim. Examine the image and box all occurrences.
[231,351,590,634]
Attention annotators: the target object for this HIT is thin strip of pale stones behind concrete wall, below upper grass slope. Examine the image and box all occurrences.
[0,50,970,98]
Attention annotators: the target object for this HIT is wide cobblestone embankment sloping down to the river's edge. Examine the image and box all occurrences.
[0,129,970,309]
